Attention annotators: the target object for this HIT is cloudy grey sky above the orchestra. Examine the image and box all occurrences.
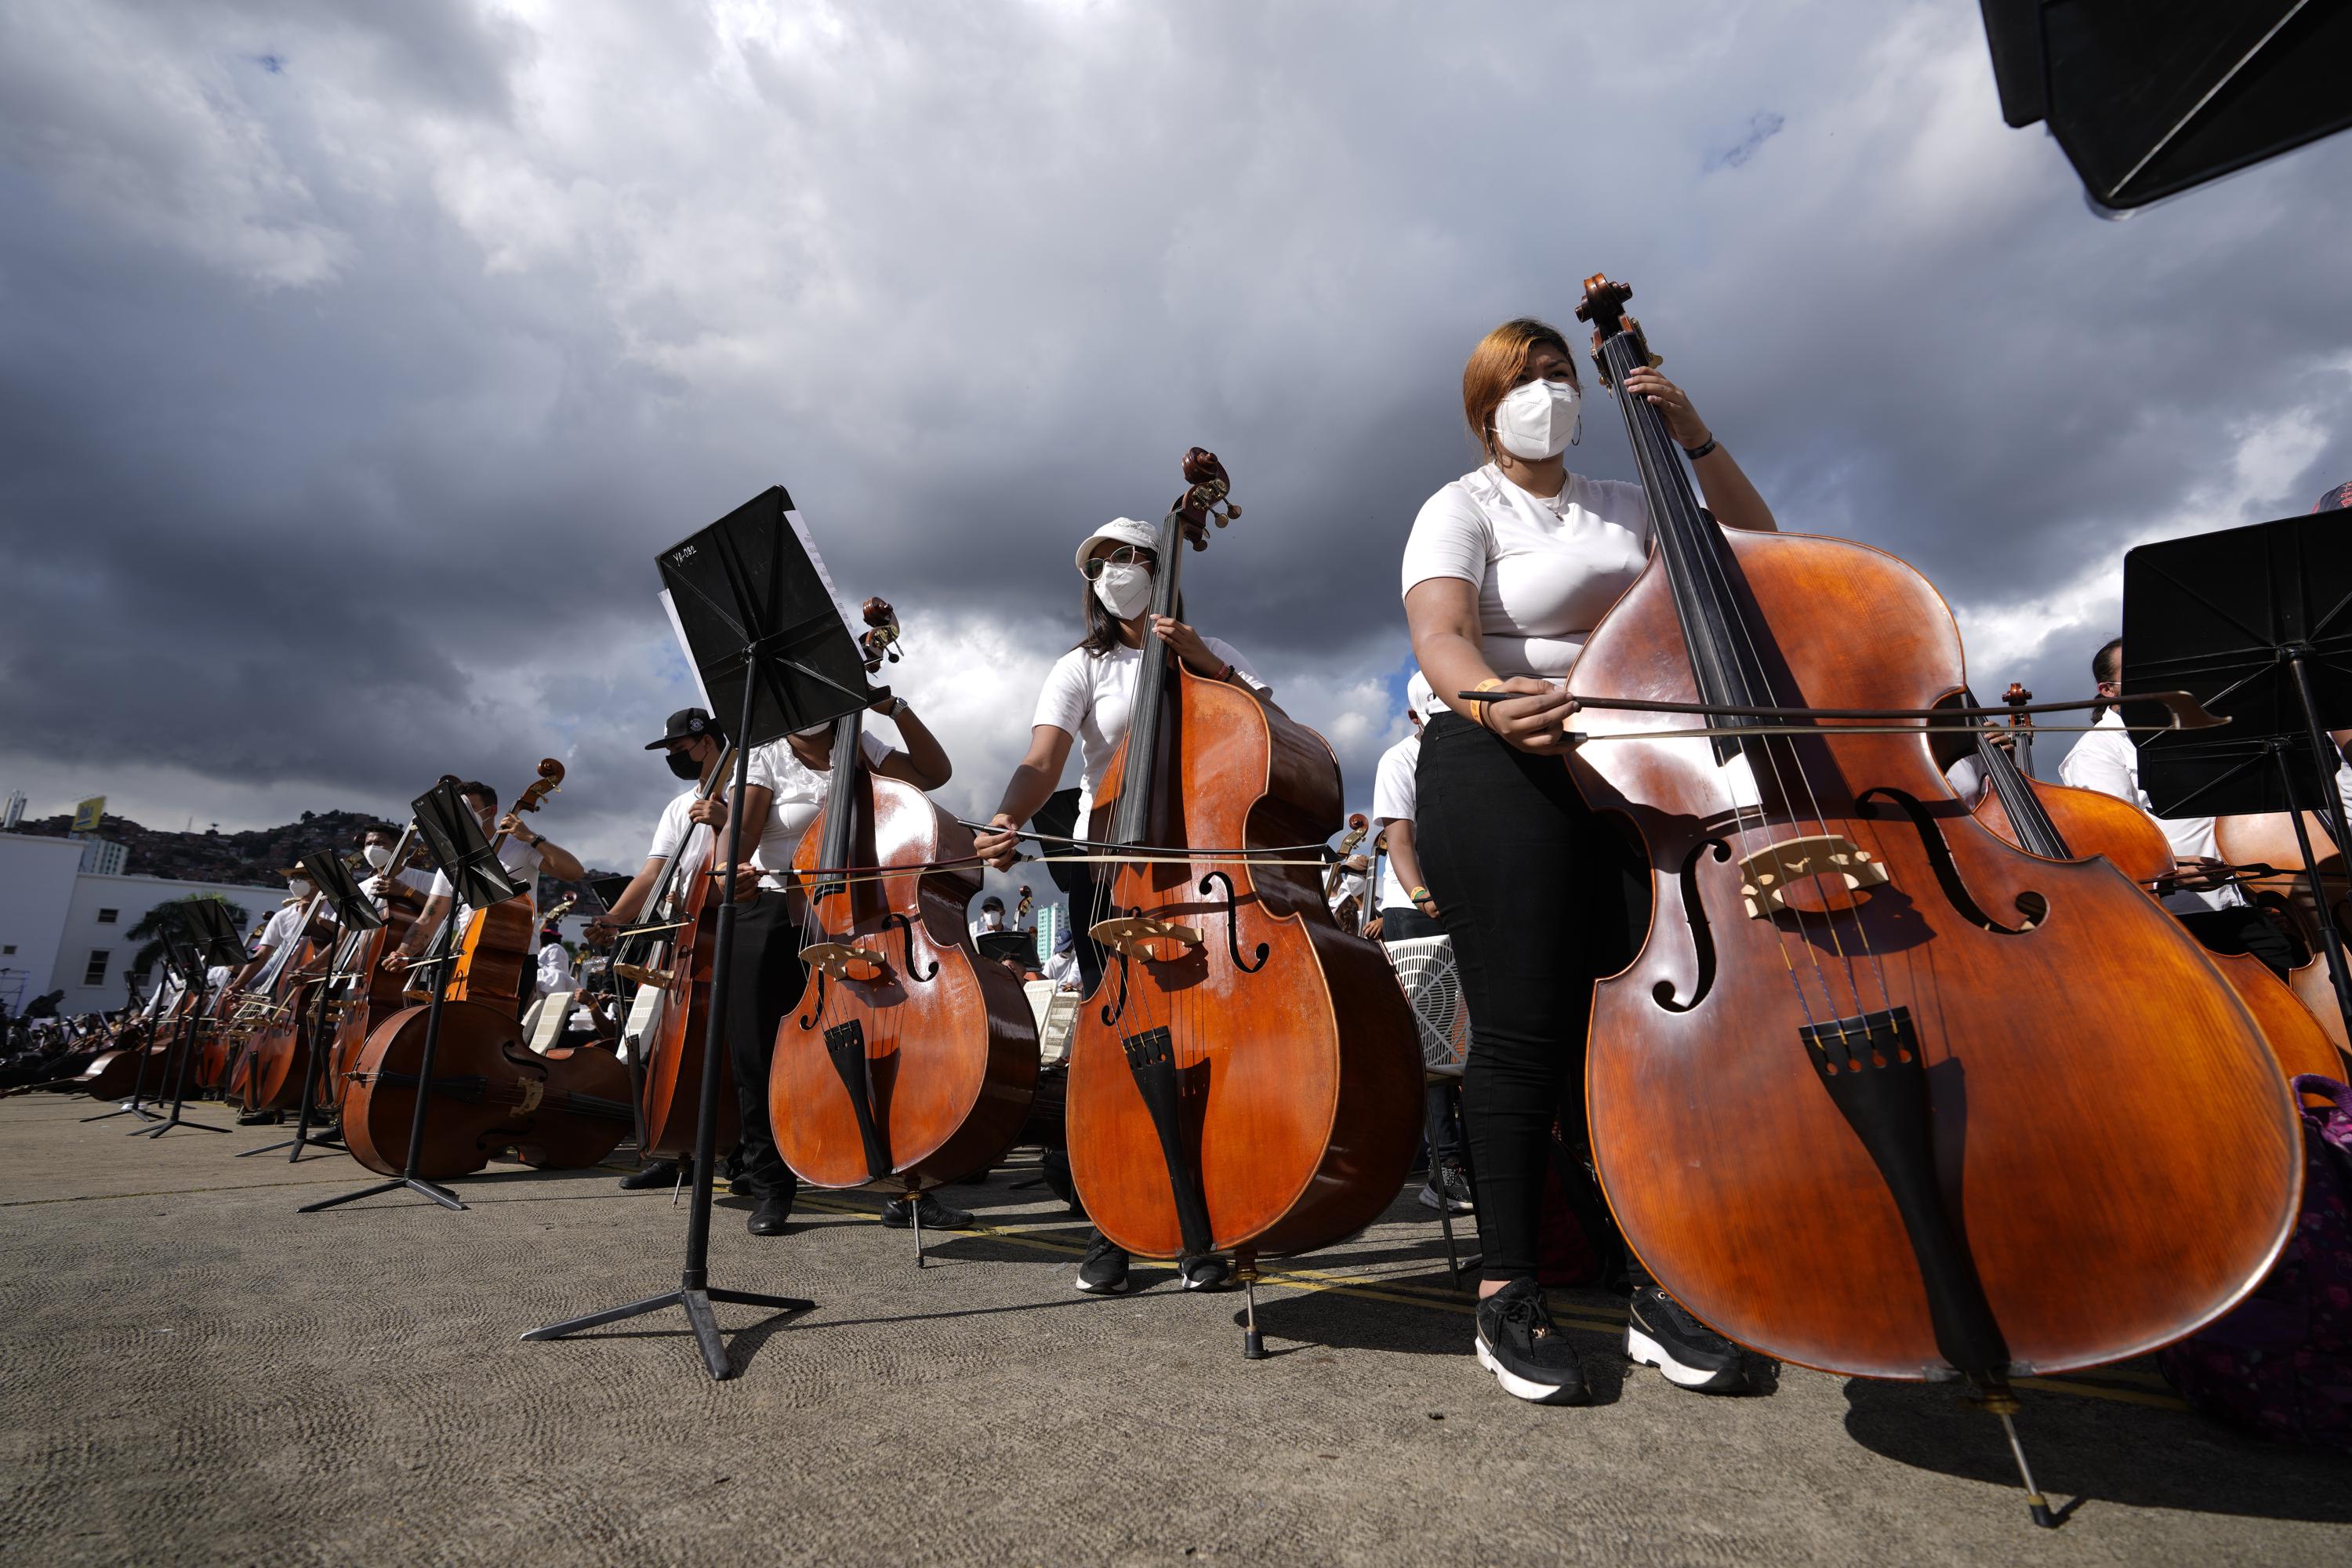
[0,0,2352,884]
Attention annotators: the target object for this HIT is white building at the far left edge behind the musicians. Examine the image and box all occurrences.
[0,832,287,1015]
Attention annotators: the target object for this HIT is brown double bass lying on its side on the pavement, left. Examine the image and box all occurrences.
[336,1001,635,1180]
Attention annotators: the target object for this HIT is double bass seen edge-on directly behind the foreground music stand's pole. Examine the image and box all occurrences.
[612,746,743,1159]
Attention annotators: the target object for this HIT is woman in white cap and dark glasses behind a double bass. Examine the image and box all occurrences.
[974,517,1272,1295]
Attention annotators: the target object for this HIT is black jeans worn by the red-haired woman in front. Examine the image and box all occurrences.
[1414,713,1646,1281]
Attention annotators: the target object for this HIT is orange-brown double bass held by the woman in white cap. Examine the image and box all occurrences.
[1068,447,1421,1359]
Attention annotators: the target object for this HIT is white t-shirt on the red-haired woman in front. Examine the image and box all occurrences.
[1404,463,1649,680]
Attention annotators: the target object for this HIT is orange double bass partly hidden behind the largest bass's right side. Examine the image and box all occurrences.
[1976,687,2345,1083]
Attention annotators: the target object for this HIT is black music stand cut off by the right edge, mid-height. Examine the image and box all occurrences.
[2124,513,2352,1027]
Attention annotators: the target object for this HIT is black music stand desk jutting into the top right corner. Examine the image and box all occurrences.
[1978,0,2352,212]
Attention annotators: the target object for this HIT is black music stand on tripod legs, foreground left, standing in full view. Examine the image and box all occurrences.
[522,485,887,1380]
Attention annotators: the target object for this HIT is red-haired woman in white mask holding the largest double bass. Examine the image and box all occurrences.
[1404,320,1773,1403]
